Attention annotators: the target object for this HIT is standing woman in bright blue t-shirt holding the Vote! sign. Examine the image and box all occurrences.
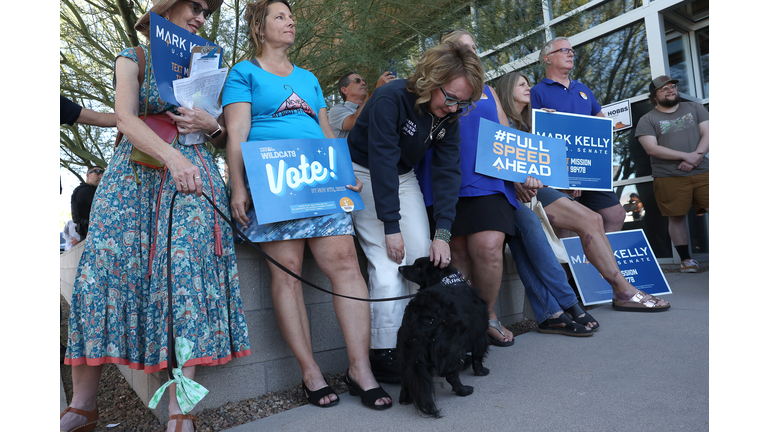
[222,0,392,409]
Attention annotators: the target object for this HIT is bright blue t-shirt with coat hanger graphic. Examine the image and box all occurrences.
[222,61,326,141]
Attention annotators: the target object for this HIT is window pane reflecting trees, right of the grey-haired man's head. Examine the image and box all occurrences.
[571,21,651,105]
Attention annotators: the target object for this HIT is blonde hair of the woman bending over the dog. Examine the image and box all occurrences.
[406,42,485,116]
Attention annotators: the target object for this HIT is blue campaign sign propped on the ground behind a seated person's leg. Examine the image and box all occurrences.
[561,229,672,306]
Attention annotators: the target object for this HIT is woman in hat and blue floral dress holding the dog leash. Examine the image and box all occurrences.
[60,0,250,432]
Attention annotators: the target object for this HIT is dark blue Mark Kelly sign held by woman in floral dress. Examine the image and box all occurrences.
[149,12,223,106]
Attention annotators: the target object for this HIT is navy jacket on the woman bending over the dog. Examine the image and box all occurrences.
[347,79,461,234]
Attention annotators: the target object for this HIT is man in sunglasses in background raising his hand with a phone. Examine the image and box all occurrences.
[328,71,397,138]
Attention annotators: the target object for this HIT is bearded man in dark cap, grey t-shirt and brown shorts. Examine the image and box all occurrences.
[635,75,709,273]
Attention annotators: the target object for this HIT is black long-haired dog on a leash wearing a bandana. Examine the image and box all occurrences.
[397,257,489,418]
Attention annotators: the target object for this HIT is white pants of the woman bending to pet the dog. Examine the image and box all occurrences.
[352,163,432,349]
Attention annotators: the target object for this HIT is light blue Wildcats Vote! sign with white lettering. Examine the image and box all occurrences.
[241,138,365,225]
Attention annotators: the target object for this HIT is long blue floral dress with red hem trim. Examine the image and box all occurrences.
[64,47,251,373]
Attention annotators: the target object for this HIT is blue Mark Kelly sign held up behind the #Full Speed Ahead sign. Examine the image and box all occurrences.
[533,110,613,191]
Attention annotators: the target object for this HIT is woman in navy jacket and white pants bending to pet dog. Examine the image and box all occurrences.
[347,44,484,382]
